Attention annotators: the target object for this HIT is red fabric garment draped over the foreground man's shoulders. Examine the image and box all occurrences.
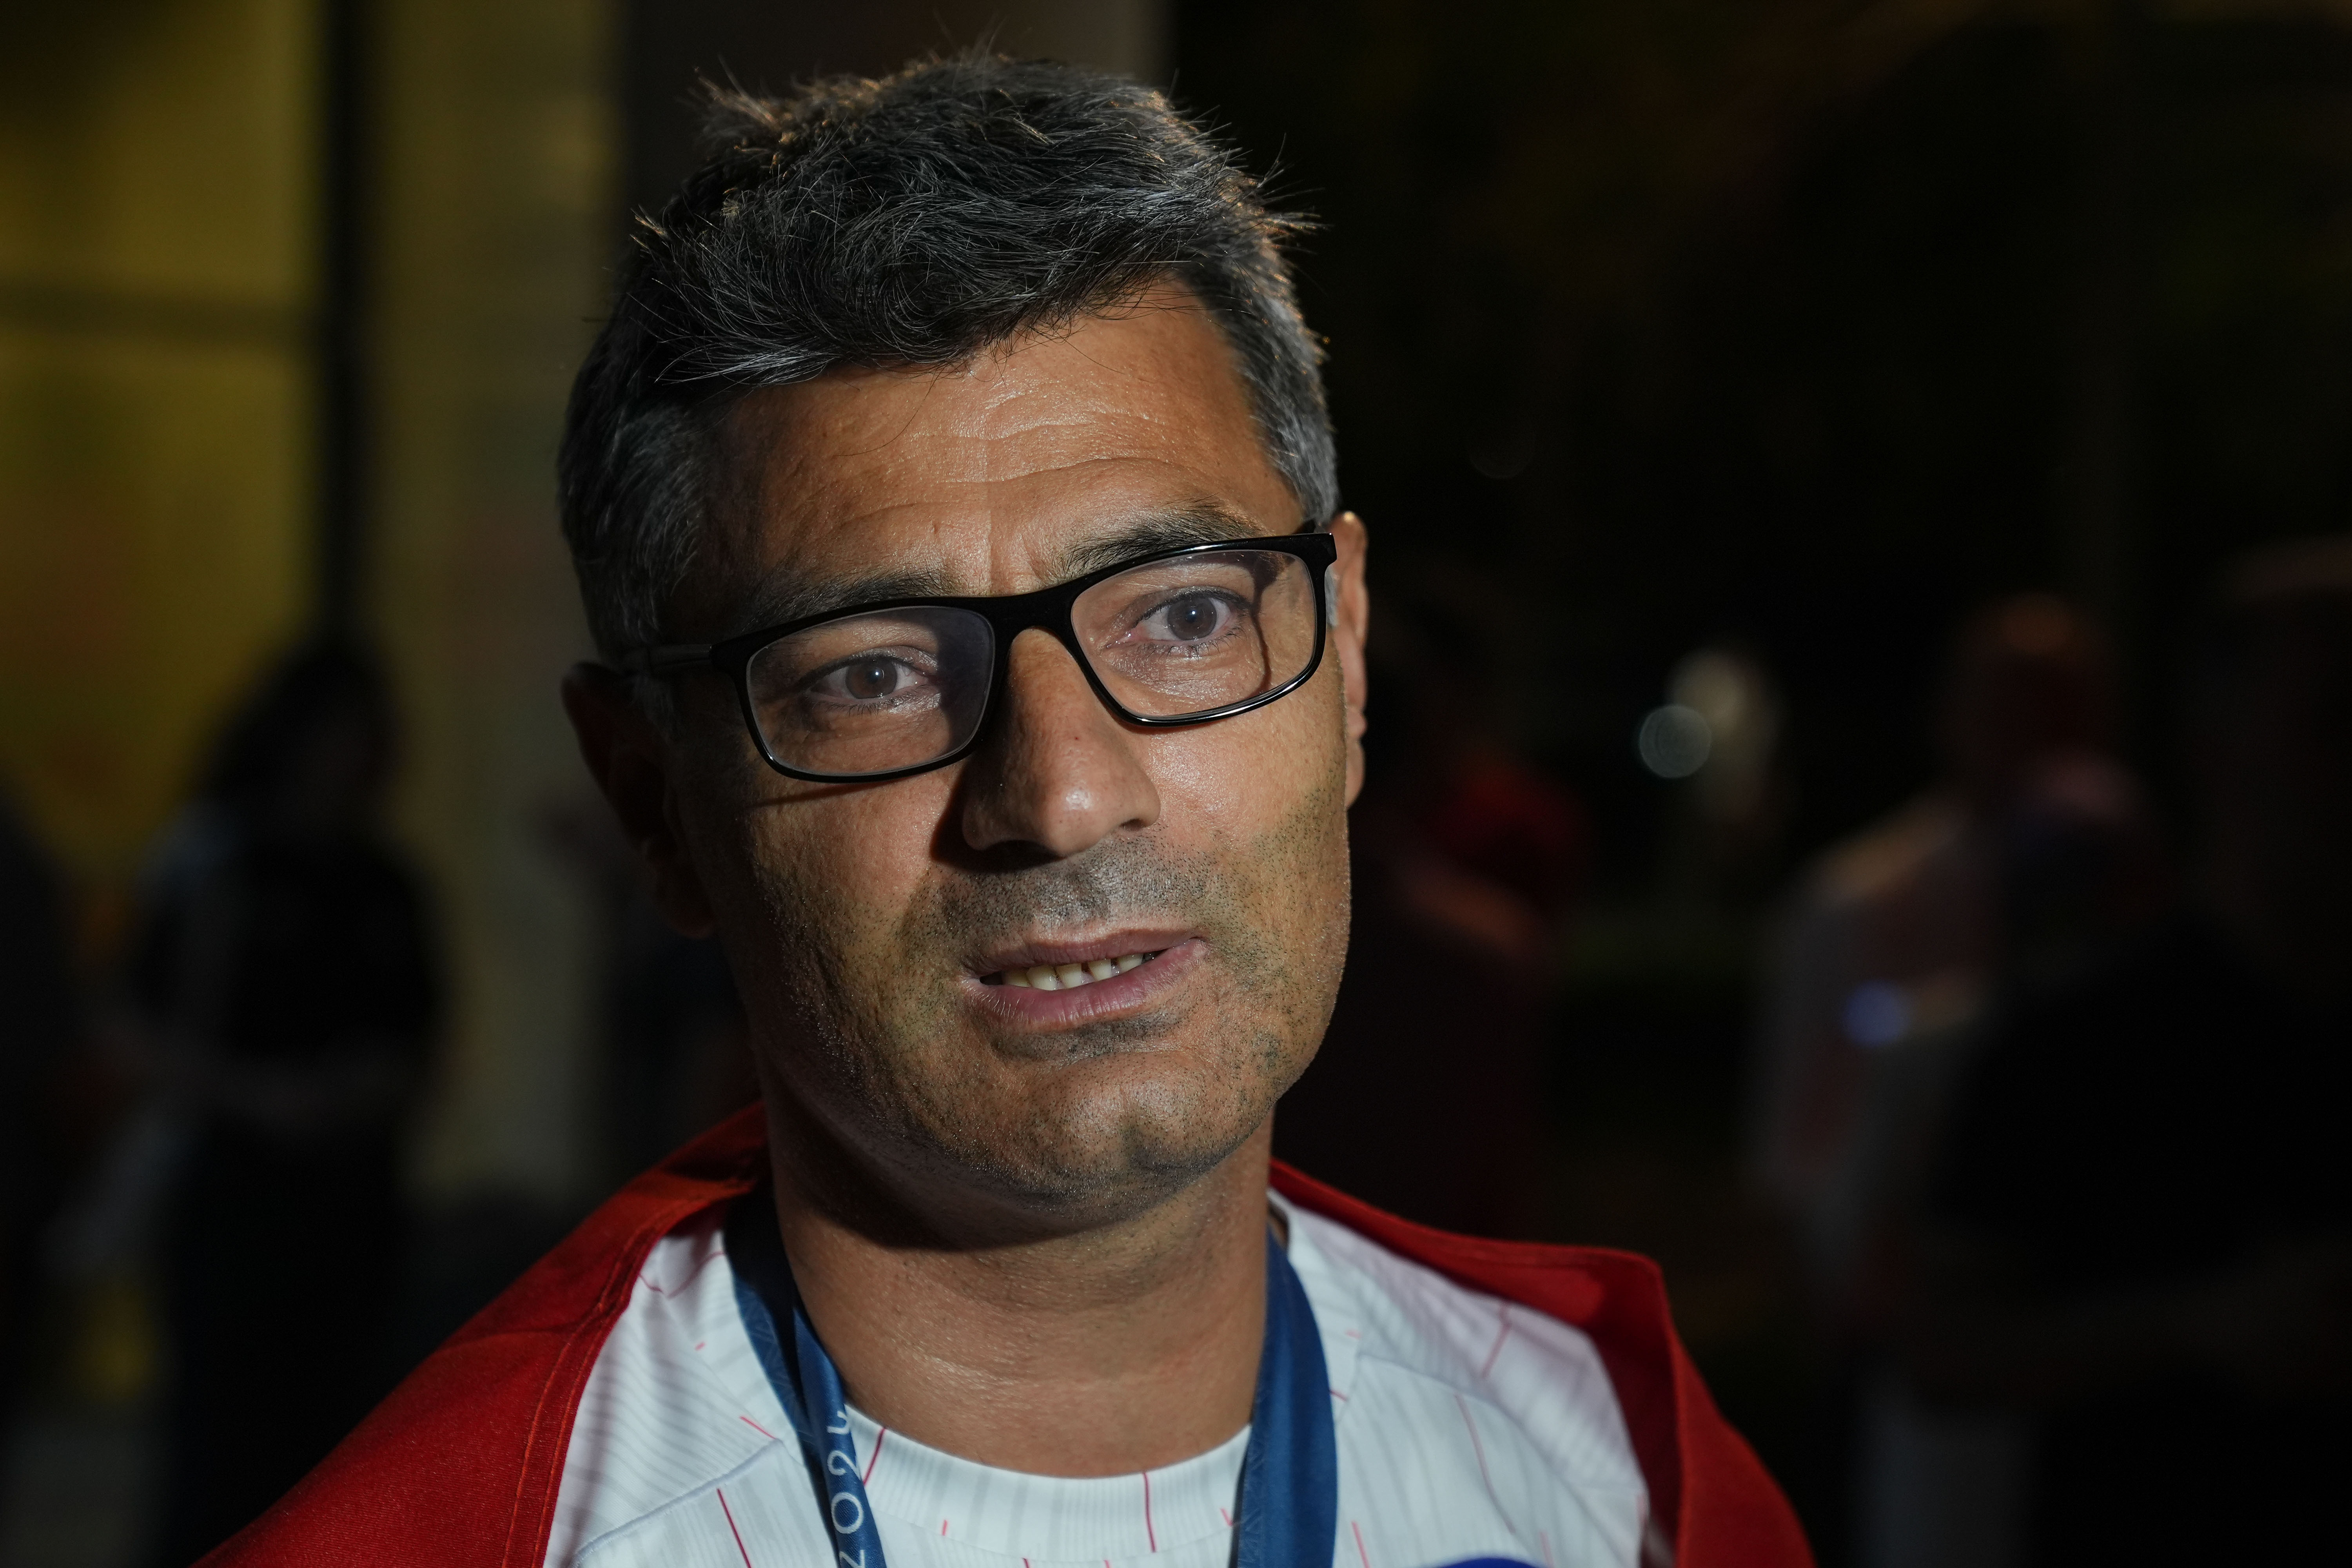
[205,1107,1813,1568]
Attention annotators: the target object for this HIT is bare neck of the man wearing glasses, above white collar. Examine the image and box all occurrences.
[771,1100,1272,1476]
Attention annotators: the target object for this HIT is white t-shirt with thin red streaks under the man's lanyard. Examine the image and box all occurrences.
[546,1199,1649,1568]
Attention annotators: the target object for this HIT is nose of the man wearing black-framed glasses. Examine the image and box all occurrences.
[964,628,1160,858]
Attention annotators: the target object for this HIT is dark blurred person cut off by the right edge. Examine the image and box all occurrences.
[1905,538,2352,1563]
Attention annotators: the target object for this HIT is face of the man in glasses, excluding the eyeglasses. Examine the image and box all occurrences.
[607,292,1364,1225]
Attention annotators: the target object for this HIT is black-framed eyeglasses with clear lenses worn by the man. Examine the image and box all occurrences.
[623,534,1338,783]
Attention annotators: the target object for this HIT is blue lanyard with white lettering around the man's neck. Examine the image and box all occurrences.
[727,1187,1338,1568]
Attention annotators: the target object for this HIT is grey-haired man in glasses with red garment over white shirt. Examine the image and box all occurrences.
[223,59,1804,1568]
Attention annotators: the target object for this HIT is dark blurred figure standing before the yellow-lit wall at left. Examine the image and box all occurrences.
[129,642,440,1566]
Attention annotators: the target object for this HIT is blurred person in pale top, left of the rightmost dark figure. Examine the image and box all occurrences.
[1755,595,2161,1568]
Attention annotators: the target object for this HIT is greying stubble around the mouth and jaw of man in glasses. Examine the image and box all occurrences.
[746,790,1348,1229]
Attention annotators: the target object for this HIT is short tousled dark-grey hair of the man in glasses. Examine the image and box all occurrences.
[557,54,1338,658]
